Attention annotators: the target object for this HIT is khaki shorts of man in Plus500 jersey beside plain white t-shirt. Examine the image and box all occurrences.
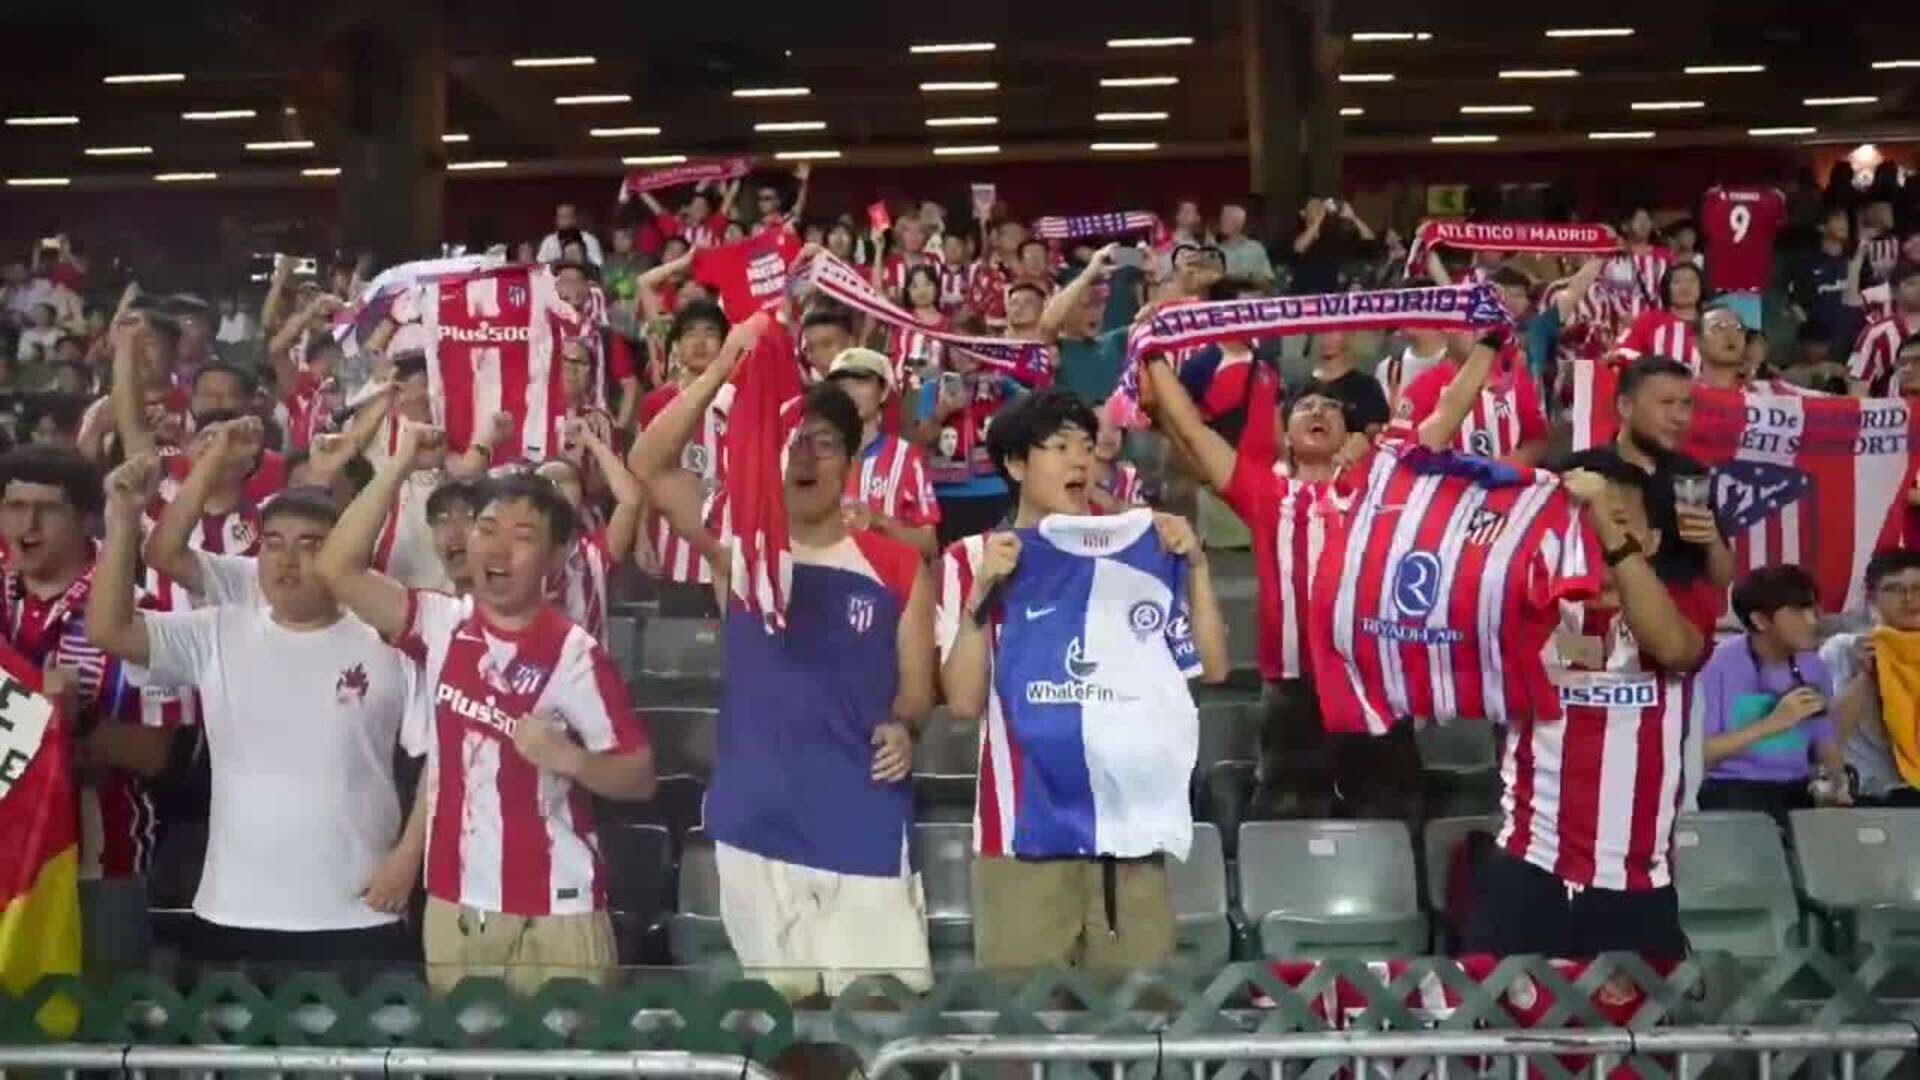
[424,896,620,994]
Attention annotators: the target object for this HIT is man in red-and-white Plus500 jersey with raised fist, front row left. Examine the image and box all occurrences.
[317,423,655,990]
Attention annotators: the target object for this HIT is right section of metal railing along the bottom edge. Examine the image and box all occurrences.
[866,1024,1920,1080]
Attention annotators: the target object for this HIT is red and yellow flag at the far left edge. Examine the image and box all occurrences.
[0,644,81,1036]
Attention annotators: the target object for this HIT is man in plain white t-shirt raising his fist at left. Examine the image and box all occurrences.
[86,434,424,978]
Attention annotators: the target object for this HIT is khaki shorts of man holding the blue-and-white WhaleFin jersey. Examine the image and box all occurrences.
[973,859,1173,974]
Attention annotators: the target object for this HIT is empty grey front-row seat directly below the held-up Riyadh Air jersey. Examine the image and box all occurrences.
[1238,821,1427,959]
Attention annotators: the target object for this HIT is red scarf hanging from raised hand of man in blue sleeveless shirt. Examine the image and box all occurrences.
[724,315,801,630]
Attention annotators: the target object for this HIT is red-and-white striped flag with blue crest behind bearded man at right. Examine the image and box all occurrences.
[1572,359,1920,611]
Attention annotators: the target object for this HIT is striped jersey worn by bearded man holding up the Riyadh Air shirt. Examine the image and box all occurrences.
[1498,580,1722,890]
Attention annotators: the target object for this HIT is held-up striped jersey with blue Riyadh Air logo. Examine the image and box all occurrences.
[1309,446,1601,734]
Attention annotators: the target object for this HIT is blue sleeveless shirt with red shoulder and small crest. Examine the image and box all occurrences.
[707,532,920,876]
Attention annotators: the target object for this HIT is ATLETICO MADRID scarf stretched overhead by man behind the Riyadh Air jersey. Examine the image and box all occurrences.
[1106,284,1509,427]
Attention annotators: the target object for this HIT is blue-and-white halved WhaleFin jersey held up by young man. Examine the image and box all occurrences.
[983,509,1200,859]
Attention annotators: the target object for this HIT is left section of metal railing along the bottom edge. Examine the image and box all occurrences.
[0,1043,778,1080]
